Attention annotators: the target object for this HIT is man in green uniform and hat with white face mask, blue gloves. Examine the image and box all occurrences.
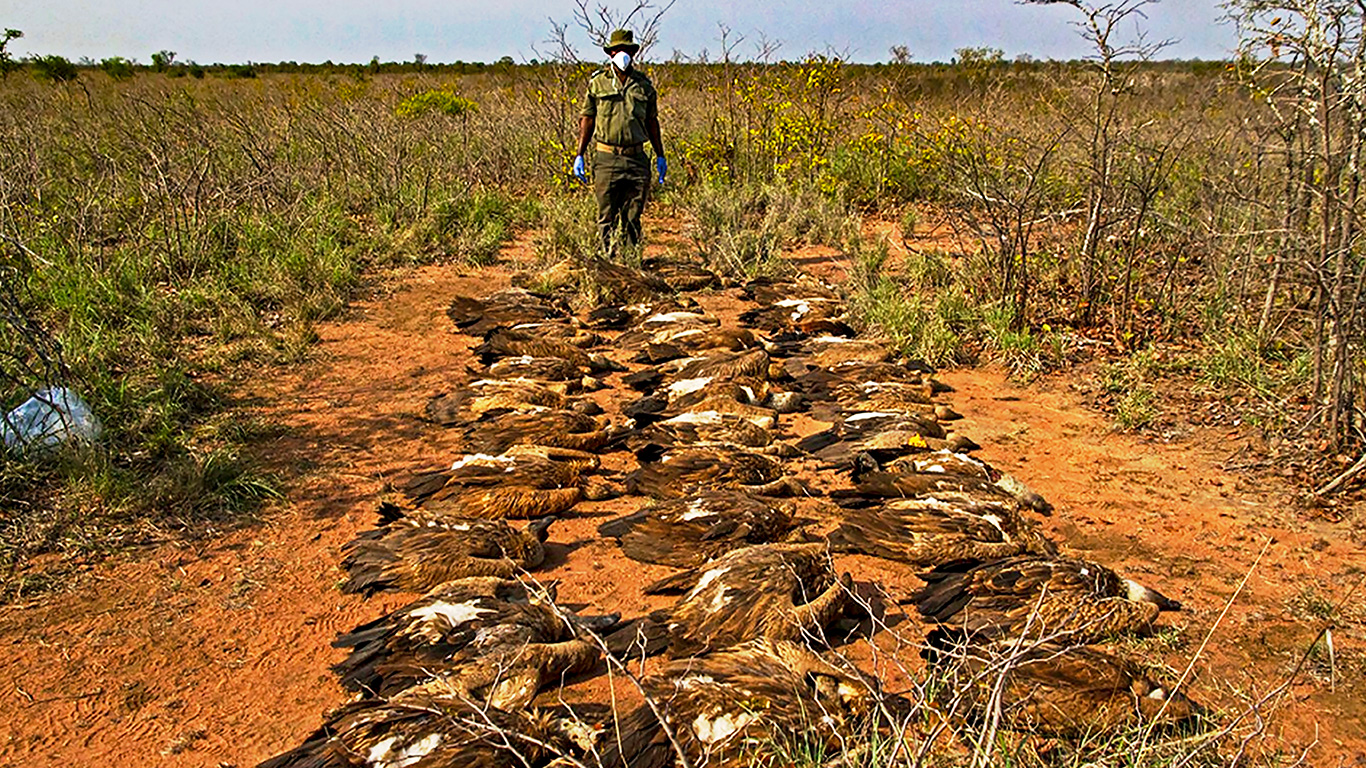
[574,29,668,254]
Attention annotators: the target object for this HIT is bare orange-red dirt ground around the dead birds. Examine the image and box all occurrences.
[0,225,1366,767]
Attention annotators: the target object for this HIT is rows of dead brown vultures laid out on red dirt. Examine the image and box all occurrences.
[262,269,1197,768]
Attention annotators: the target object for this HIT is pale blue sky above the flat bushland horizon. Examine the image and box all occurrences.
[0,0,1233,63]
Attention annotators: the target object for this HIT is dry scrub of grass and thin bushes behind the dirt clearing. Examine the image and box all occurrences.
[0,3,1366,597]
